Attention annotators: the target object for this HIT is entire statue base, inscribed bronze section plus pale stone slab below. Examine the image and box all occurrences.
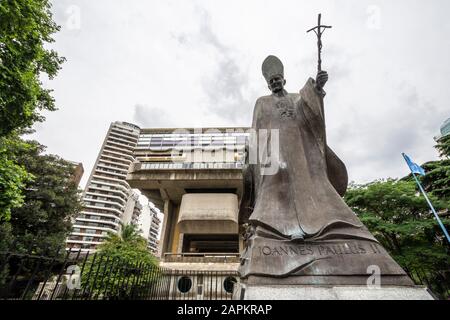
[233,235,434,300]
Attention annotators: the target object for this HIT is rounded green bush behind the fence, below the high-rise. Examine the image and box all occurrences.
[81,225,160,299]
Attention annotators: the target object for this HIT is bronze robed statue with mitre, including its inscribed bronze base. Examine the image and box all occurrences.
[239,56,409,283]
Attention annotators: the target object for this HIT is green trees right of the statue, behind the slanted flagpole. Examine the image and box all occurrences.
[345,179,450,271]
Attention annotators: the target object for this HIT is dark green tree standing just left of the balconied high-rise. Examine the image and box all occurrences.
[3,141,82,254]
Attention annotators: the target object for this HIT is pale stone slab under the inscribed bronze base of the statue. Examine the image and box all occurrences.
[233,283,434,300]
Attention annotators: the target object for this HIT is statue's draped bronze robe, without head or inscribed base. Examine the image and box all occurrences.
[239,79,376,241]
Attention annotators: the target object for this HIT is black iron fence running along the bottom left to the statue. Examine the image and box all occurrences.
[0,250,239,300]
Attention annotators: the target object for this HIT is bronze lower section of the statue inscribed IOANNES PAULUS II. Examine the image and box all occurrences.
[239,235,413,285]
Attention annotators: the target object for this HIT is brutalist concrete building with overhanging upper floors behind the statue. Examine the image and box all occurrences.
[126,128,248,271]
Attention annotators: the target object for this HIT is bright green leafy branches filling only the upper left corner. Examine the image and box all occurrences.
[0,0,65,137]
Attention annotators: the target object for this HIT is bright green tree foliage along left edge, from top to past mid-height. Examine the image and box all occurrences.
[0,0,65,223]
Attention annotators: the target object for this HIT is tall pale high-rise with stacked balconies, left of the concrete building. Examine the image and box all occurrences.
[67,122,142,251]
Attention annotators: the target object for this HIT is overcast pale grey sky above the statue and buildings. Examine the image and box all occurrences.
[33,0,450,187]
